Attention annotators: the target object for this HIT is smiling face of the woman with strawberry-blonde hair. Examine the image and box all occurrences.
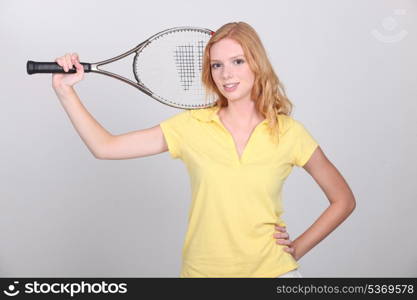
[210,38,255,101]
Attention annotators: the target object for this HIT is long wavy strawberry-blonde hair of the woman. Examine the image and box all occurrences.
[202,22,293,141]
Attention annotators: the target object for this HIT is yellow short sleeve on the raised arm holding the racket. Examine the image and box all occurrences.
[159,111,189,159]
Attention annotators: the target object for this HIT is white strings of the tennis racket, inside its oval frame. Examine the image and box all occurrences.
[134,30,214,108]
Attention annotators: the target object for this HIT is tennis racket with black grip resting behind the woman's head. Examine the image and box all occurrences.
[26,27,215,109]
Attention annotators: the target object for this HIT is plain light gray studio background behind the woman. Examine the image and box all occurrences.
[0,0,417,277]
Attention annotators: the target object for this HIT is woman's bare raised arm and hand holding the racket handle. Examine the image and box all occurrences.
[52,53,168,159]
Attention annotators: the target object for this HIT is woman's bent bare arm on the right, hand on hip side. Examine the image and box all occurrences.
[293,146,356,260]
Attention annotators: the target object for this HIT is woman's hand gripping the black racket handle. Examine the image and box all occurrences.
[52,53,84,91]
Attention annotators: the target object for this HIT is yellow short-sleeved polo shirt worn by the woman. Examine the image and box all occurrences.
[160,106,318,277]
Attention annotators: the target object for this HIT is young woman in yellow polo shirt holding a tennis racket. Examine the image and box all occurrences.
[53,22,355,277]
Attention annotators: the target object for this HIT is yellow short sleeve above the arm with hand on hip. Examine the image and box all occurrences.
[293,120,319,167]
